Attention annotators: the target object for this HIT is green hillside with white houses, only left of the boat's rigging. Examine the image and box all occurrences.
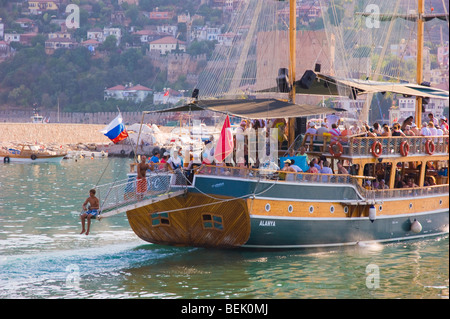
[0,0,246,116]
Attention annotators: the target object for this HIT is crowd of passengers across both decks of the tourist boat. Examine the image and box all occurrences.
[136,113,448,190]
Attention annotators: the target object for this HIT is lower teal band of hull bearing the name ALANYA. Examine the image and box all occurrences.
[244,210,449,248]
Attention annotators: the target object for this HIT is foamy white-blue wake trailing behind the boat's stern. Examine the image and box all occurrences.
[0,241,195,299]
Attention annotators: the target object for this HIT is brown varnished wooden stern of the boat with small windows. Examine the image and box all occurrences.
[127,193,250,248]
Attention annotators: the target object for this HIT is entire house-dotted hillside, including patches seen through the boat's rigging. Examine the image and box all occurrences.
[0,0,449,124]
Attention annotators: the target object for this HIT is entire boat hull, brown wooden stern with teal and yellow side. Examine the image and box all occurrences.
[127,176,449,249]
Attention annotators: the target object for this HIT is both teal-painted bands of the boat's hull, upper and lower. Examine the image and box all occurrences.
[190,176,449,248]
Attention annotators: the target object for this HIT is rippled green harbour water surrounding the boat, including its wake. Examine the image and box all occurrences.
[0,159,449,299]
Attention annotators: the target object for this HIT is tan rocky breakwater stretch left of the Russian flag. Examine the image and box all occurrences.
[0,123,110,151]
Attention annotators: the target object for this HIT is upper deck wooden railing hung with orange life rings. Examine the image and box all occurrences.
[302,134,449,157]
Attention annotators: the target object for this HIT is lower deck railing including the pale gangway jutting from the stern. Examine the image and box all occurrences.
[95,165,449,217]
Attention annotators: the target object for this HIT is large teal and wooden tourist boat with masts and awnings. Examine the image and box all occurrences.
[99,0,449,249]
